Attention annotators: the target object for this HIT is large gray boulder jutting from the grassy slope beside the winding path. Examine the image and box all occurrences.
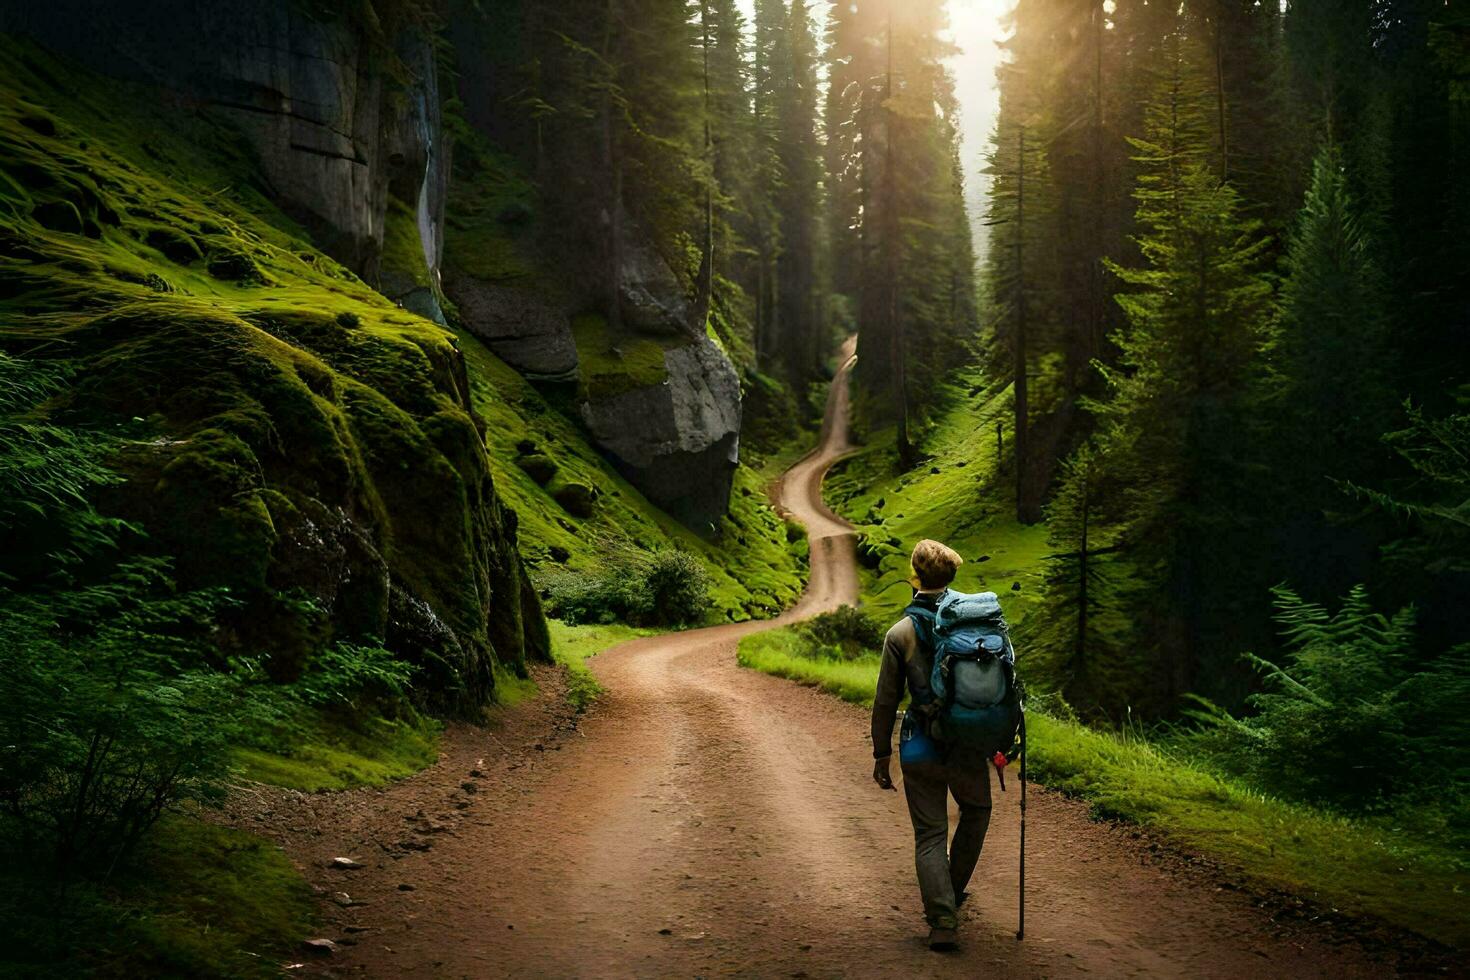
[582,338,741,530]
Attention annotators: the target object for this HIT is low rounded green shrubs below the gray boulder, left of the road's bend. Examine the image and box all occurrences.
[545,551,710,626]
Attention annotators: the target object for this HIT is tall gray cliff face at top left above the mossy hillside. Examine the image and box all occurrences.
[0,0,448,282]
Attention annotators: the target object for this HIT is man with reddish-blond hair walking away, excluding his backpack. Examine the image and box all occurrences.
[873,539,991,951]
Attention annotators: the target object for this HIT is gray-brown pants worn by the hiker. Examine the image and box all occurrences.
[903,758,991,929]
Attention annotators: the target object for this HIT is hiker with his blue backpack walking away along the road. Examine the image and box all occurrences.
[873,539,1020,951]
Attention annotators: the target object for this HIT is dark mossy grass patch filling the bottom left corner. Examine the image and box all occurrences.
[0,817,315,977]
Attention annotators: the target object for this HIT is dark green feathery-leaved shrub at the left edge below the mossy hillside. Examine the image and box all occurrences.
[0,575,263,874]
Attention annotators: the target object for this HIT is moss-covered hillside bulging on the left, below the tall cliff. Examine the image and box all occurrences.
[0,41,548,705]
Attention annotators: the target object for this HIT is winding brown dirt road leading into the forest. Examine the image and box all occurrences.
[258,334,1386,977]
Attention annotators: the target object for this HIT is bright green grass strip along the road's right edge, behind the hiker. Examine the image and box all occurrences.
[738,627,1470,946]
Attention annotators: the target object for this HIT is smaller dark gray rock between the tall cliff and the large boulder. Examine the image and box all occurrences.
[444,276,576,381]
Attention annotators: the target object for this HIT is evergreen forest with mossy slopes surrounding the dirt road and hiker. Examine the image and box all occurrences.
[0,0,1470,976]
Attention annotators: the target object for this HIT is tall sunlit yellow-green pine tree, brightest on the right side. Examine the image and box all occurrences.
[1092,38,1270,710]
